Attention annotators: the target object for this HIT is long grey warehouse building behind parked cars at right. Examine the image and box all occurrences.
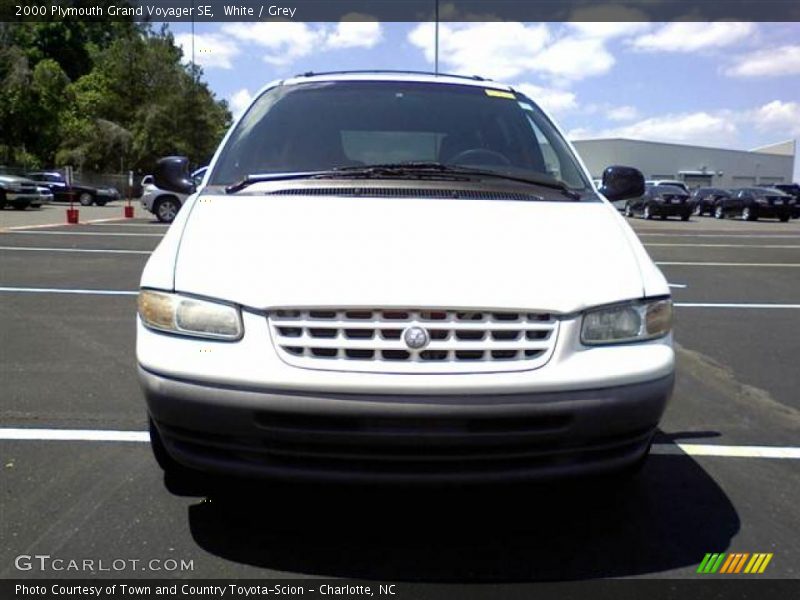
[572,138,796,188]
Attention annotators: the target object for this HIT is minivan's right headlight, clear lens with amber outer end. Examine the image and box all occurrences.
[581,298,672,346]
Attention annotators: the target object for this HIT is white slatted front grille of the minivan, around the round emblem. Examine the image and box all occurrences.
[268,307,558,373]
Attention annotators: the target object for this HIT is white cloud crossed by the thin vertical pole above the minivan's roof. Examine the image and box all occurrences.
[408,22,550,79]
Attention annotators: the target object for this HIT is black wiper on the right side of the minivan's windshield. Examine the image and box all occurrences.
[313,161,581,200]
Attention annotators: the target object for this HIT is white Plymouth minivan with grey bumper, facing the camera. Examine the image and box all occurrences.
[136,72,674,481]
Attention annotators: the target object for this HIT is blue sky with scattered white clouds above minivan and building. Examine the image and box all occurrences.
[170,21,800,179]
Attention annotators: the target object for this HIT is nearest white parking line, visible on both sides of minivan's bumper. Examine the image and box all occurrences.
[0,427,800,459]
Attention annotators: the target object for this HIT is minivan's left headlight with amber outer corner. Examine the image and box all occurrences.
[138,290,243,340]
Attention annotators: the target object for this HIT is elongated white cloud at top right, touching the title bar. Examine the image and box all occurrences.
[632,21,757,52]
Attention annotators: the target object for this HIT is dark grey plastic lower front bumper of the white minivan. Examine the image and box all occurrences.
[139,366,674,481]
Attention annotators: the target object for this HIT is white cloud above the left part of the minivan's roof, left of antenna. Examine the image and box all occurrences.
[222,21,383,67]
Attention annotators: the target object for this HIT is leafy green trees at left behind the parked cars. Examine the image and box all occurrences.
[0,19,231,172]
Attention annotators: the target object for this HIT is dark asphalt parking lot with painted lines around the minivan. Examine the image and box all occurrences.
[0,204,800,582]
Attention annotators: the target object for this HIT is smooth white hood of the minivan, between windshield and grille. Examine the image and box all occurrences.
[175,193,643,313]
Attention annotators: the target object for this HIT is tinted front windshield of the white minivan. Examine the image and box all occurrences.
[209,81,587,190]
